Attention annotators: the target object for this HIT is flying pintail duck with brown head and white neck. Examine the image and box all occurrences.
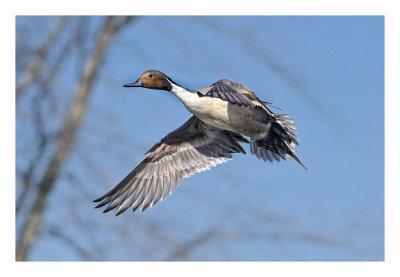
[94,70,306,215]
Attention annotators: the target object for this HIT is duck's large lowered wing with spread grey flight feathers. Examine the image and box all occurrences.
[94,116,248,215]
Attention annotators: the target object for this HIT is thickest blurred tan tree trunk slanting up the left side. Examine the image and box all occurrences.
[16,17,131,261]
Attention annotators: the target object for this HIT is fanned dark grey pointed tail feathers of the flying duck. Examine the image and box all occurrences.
[250,112,307,170]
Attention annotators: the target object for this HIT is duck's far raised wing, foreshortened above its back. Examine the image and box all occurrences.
[199,79,263,107]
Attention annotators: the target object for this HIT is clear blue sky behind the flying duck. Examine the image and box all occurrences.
[17,16,384,261]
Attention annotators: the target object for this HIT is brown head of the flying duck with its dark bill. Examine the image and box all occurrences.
[124,70,172,91]
